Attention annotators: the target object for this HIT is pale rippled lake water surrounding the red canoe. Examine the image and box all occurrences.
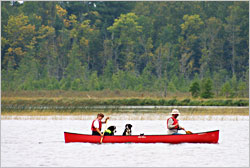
[1,115,249,167]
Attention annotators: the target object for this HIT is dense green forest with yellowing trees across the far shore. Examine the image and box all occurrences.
[1,1,249,98]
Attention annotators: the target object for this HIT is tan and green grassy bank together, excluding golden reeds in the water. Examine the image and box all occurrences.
[1,90,249,112]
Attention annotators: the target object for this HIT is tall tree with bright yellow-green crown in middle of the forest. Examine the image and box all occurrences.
[108,13,142,71]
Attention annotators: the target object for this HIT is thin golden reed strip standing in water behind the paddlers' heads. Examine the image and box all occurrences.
[1,108,249,117]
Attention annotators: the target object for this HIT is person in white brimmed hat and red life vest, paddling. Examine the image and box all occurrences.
[167,109,185,135]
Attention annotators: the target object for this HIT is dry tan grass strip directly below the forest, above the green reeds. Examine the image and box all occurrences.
[1,90,191,99]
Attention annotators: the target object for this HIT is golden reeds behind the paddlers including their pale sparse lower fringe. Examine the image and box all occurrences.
[1,108,249,120]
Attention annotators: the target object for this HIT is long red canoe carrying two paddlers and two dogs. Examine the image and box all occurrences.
[64,130,219,143]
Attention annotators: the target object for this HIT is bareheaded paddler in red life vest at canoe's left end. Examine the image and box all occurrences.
[91,113,109,136]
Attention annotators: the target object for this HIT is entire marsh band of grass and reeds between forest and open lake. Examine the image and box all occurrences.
[1,90,249,120]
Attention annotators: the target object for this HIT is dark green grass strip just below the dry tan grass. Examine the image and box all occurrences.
[1,98,248,110]
